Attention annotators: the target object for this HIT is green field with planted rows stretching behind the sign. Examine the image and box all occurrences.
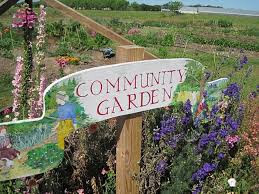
[0,8,259,110]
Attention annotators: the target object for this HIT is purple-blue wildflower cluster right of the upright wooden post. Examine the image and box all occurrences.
[140,80,244,193]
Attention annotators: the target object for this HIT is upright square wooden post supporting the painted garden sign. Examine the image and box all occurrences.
[116,45,144,194]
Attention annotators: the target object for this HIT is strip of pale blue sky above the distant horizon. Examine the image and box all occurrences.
[129,0,259,11]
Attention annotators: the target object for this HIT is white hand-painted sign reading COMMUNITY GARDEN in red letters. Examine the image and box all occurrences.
[0,59,207,181]
